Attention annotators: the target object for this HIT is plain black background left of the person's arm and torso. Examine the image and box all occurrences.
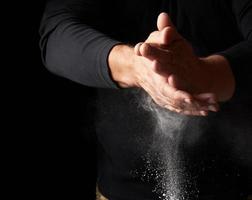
[10,0,96,200]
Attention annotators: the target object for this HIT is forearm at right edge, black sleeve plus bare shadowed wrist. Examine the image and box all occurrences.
[204,0,252,100]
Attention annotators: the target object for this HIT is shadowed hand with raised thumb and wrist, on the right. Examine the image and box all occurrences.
[135,13,235,101]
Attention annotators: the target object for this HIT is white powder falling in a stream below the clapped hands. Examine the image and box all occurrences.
[142,96,199,200]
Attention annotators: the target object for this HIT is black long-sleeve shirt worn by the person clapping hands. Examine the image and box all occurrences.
[40,0,252,200]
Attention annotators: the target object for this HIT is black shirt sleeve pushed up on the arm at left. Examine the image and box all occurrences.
[39,0,120,88]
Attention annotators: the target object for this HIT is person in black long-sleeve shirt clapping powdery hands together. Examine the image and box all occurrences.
[40,0,252,200]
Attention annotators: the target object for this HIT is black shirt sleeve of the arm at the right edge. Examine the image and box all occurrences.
[219,0,252,99]
